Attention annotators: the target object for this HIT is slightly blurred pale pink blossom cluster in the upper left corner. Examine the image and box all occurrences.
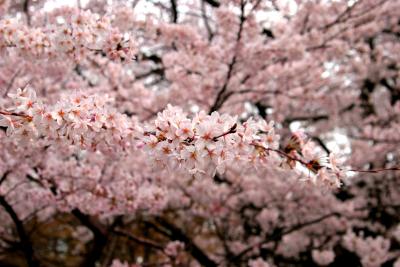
[0,10,136,61]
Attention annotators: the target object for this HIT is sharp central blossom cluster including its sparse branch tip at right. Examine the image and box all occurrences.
[144,105,344,188]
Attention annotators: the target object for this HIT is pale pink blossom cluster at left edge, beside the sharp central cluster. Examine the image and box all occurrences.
[0,88,133,151]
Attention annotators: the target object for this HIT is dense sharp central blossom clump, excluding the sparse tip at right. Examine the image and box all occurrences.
[144,105,279,178]
